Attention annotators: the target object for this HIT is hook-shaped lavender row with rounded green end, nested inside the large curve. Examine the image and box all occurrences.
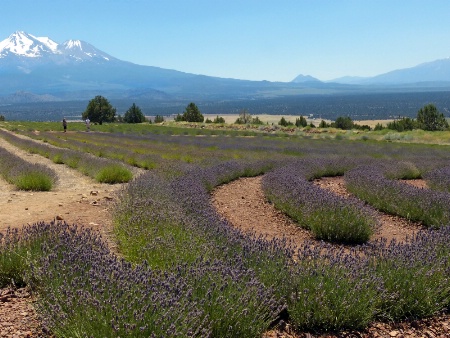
[263,159,376,244]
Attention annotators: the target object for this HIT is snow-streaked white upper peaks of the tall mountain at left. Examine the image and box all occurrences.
[0,31,115,63]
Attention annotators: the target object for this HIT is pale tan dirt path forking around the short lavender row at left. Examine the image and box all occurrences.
[0,132,141,246]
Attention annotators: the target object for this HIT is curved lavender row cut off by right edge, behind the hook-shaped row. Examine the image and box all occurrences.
[345,162,450,228]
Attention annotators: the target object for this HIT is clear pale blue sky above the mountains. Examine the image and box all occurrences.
[0,0,450,81]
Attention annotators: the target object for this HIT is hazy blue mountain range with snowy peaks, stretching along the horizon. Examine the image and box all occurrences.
[0,31,450,104]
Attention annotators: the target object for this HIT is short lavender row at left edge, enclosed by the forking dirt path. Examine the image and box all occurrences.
[0,147,57,191]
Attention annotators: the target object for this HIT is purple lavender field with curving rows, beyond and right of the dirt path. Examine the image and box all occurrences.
[0,125,450,337]
